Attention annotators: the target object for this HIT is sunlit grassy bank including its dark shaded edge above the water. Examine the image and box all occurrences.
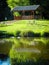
[0,20,49,37]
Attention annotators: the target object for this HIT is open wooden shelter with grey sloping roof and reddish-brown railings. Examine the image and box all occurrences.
[12,5,42,20]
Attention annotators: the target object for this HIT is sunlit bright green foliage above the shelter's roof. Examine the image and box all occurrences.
[7,0,29,9]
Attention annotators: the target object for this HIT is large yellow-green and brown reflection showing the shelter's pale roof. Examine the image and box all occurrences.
[10,38,49,65]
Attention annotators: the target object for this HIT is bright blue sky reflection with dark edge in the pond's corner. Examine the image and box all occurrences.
[0,54,10,65]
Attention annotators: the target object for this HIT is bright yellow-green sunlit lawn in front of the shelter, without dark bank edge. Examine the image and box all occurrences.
[0,20,49,35]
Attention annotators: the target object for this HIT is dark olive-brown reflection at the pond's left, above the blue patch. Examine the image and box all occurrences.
[0,39,13,54]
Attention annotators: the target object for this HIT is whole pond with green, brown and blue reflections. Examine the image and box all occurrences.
[0,37,49,65]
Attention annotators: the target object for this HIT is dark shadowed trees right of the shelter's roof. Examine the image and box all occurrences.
[29,0,49,19]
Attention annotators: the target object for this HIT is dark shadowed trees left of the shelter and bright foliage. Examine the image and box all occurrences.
[0,0,13,21]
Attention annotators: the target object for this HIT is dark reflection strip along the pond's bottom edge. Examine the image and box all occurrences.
[11,59,49,65]
